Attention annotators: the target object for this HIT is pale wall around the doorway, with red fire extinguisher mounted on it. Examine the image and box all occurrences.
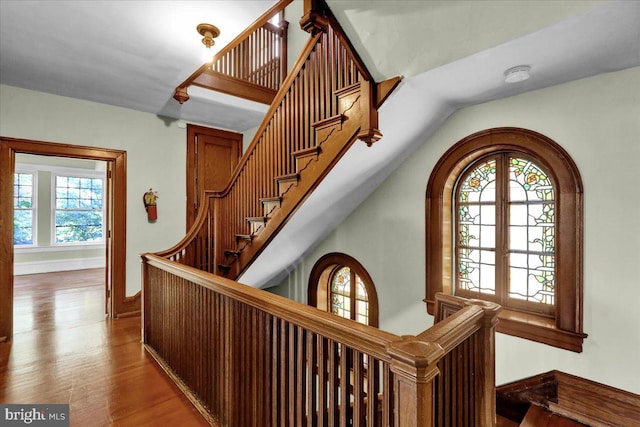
[0,85,186,295]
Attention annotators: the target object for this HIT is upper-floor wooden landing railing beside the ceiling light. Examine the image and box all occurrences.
[173,0,293,104]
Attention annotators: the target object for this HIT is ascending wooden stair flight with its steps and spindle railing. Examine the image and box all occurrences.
[157,1,390,278]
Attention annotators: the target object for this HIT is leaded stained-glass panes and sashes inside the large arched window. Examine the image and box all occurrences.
[455,153,555,312]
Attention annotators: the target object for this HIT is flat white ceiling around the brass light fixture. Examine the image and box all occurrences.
[0,0,275,131]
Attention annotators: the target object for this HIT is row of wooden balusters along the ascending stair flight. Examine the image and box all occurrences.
[217,28,362,264]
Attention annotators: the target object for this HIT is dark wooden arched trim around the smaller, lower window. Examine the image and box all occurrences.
[307,252,379,327]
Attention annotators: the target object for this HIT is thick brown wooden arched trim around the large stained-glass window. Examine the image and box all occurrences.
[425,128,587,352]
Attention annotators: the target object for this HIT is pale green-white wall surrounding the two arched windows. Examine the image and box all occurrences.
[274,68,640,394]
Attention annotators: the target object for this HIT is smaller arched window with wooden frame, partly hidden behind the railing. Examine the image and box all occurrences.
[308,253,378,327]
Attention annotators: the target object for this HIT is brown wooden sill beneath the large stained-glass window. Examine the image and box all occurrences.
[426,301,587,353]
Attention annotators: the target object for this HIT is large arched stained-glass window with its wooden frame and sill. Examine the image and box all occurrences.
[426,128,586,352]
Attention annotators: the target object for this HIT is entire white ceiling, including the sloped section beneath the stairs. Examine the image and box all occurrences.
[0,0,640,286]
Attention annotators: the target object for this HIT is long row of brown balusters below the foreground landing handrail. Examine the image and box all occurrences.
[144,265,394,427]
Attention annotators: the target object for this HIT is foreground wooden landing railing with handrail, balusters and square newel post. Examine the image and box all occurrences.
[142,254,500,427]
